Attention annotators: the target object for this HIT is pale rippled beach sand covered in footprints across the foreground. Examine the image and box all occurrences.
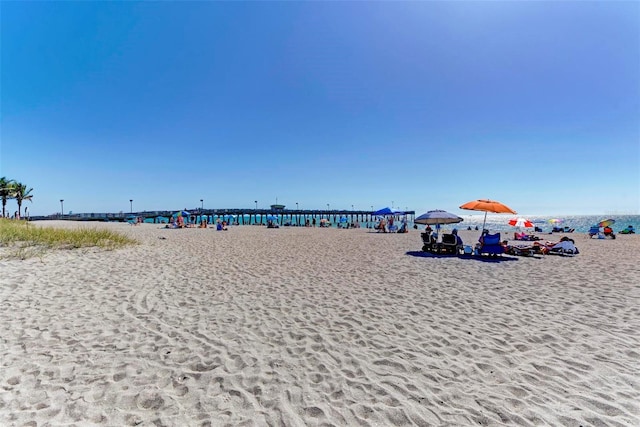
[0,221,640,426]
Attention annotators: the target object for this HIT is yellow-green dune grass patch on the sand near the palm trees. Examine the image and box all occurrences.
[0,219,136,259]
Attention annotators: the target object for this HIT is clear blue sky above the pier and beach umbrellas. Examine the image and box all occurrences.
[0,1,640,215]
